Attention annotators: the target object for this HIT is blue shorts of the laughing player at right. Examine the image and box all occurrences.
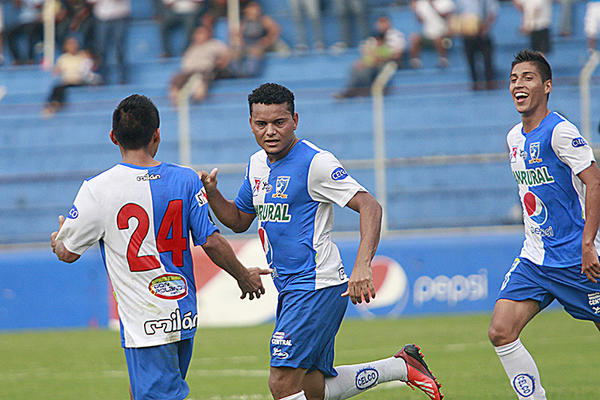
[497,258,600,322]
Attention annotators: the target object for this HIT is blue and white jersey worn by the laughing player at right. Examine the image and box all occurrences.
[507,112,600,268]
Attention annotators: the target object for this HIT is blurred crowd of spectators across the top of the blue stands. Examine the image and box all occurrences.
[0,0,600,113]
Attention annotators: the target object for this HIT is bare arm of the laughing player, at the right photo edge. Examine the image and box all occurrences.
[577,162,600,283]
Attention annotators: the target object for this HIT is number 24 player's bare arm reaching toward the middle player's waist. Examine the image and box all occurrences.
[202,232,271,300]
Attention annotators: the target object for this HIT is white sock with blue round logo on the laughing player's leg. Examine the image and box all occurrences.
[495,339,546,400]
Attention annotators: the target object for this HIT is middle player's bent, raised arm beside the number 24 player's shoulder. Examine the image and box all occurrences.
[199,168,256,233]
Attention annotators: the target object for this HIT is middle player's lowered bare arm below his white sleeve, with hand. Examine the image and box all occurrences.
[343,192,382,304]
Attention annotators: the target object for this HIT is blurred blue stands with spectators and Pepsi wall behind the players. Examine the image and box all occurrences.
[0,0,600,330]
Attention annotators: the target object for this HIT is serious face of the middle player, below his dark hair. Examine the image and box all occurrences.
[250,103,298,162]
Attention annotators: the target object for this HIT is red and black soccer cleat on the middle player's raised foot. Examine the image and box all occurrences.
[394,344,444,400]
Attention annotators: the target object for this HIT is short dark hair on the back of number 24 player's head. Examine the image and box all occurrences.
[113,94,160,150]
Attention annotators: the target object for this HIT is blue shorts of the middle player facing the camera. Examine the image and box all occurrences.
[271,283,348,376]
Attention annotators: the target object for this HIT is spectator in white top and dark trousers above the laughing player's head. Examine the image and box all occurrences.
[513,0,552,53]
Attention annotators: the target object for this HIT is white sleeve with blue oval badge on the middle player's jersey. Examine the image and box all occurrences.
[307,152,367,207]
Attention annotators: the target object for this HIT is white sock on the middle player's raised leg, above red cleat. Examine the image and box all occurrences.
[325,357,407,400]
